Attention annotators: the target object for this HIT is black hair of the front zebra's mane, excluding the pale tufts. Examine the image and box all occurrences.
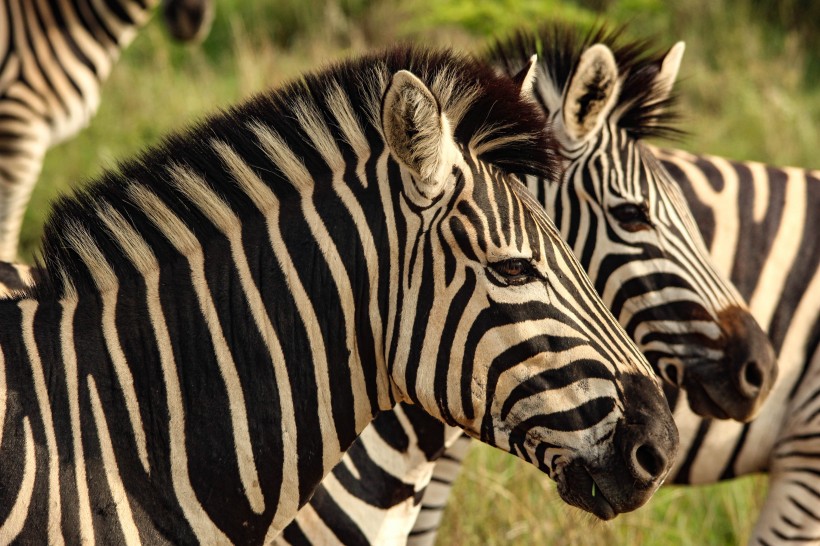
[26,47,557,297]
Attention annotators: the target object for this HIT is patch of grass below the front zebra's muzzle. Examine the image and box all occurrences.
[438,444,766,546]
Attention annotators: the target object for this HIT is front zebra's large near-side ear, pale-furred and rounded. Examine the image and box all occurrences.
[382,70,459,199]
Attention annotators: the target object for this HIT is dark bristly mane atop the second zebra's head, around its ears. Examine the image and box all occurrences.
[484,22,684,139]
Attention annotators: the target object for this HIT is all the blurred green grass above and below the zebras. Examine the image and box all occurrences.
[27,0,820,546]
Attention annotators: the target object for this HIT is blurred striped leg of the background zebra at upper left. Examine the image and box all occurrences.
[0,121,49,262]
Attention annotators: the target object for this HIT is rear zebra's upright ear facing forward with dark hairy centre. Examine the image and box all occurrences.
[562,44,620,140]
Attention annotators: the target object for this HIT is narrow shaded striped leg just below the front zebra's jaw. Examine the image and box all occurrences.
[407,434,472,546]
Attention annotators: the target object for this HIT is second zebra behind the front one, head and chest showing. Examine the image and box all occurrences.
[272,26,776,544]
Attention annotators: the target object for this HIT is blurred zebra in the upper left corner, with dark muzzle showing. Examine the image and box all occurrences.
[0,0,213,262]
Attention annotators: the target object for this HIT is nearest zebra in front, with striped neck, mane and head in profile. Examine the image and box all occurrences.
[0,47,677,544]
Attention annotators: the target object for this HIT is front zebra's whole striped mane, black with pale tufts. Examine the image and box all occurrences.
[25,46,557,297]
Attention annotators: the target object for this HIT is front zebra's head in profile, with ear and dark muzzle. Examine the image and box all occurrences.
[382,61,677,519]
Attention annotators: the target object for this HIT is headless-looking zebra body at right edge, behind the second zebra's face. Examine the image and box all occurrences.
[653,144,820,546]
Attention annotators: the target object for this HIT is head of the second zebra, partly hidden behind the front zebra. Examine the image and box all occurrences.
[491,26,777,421]
